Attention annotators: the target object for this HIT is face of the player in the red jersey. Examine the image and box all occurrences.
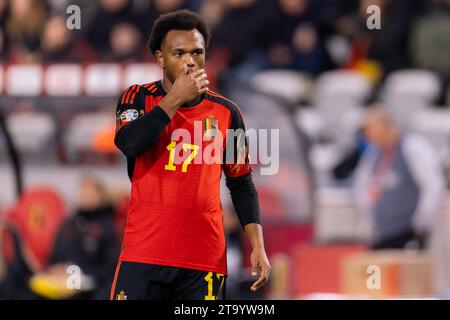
[156,29,205,83]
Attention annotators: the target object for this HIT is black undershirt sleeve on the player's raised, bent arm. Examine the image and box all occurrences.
[114,106,170,158]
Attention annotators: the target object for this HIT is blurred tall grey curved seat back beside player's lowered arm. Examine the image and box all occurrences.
[232,91,311,221]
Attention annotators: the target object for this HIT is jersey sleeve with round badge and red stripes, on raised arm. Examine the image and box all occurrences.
[116,84,145,134]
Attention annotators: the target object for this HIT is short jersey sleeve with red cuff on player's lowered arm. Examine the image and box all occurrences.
[223,106,252,178]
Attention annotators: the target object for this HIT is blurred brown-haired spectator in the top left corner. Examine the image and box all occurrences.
[5,0,47,62]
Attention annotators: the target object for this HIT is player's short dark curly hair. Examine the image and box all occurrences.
[148,10,211,54]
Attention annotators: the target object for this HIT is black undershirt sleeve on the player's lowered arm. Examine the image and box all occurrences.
[225,173,261,228]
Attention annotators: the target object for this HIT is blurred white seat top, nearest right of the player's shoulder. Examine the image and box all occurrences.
[251,70,313,103]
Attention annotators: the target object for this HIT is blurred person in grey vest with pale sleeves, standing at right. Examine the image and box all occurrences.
[355,107,445,249]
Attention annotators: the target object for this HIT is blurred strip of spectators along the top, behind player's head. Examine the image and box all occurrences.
[0,0,450,87]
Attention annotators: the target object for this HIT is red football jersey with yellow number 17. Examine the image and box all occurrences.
[116,81,251,274]
